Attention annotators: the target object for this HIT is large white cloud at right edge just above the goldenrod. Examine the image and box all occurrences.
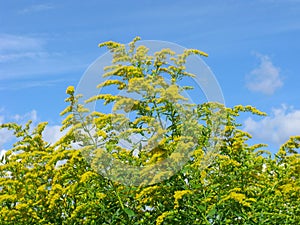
[245,105,300,145]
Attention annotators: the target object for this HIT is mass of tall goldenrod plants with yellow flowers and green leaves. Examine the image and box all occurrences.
[0,38,300,225]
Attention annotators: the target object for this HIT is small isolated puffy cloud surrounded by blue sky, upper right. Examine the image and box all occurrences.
[246,54,283,95]
